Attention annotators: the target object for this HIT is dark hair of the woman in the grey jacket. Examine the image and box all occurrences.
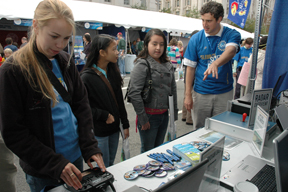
[135,29,169,63]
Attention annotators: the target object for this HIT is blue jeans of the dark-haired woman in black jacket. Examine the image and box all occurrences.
[95,131,119,167]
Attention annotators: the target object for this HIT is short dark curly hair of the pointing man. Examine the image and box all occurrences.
[200,1,224,21]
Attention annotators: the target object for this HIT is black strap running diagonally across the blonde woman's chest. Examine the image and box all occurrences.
[39,61,72,103]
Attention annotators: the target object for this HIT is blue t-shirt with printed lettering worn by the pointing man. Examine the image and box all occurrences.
[184,26,241,94]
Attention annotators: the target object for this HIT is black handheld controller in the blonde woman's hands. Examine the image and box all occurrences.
[64,167,116,192]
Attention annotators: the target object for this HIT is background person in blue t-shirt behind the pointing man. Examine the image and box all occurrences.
[233,37,253,99]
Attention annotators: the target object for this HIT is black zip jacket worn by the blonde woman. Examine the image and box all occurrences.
[0,50,101,179]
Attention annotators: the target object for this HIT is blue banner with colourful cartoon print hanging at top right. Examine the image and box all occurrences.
[228,0,251,29]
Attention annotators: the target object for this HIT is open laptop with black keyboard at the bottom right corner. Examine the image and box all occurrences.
[223,127,288,192]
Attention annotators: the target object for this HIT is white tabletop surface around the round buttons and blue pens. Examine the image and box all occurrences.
[50,124,280,192]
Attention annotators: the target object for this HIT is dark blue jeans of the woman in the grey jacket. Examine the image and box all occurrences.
[138,111,169,153]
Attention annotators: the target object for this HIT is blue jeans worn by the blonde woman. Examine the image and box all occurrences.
[25,156,83,192]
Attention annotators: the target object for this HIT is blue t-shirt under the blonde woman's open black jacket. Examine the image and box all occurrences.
[51,59,81,163]
